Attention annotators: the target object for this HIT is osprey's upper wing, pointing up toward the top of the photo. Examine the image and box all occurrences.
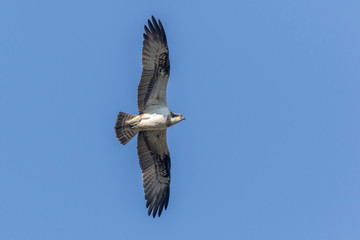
[138,17,170,114]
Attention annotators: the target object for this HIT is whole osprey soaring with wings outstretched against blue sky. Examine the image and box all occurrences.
[115,17,185,218]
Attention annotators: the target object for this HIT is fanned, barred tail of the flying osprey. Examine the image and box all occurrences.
[115,112,140,145]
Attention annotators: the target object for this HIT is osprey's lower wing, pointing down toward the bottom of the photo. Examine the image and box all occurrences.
[137,130,171,217]
